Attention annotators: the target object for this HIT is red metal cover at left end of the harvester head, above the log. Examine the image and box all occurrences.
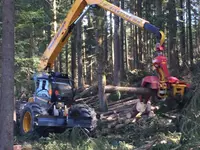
[141,76,159,89]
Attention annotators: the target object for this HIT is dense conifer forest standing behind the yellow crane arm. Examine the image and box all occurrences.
[0,0,200,97]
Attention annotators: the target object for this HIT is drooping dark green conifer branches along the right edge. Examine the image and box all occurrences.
[176,62,200,150]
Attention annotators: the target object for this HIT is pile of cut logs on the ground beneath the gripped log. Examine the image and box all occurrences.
[77,96,151,132]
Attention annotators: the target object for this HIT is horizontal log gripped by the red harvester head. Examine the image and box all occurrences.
[105,85,151,95]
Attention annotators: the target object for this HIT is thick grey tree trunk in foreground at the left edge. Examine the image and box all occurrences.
[0,0,14,150]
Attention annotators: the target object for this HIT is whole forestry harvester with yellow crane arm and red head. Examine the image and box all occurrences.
[20,0,190,134]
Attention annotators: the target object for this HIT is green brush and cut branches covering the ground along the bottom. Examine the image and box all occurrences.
[15,117,181,150]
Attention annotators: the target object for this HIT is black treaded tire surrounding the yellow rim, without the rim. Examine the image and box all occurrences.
[20,102,42,135]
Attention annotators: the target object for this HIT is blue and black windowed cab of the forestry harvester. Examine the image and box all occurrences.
[34,73,73,104]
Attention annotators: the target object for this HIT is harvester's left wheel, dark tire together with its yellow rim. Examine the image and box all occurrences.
[20,102,42,135]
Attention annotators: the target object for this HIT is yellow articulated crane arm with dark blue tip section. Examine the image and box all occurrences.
[38,0,165,71]
